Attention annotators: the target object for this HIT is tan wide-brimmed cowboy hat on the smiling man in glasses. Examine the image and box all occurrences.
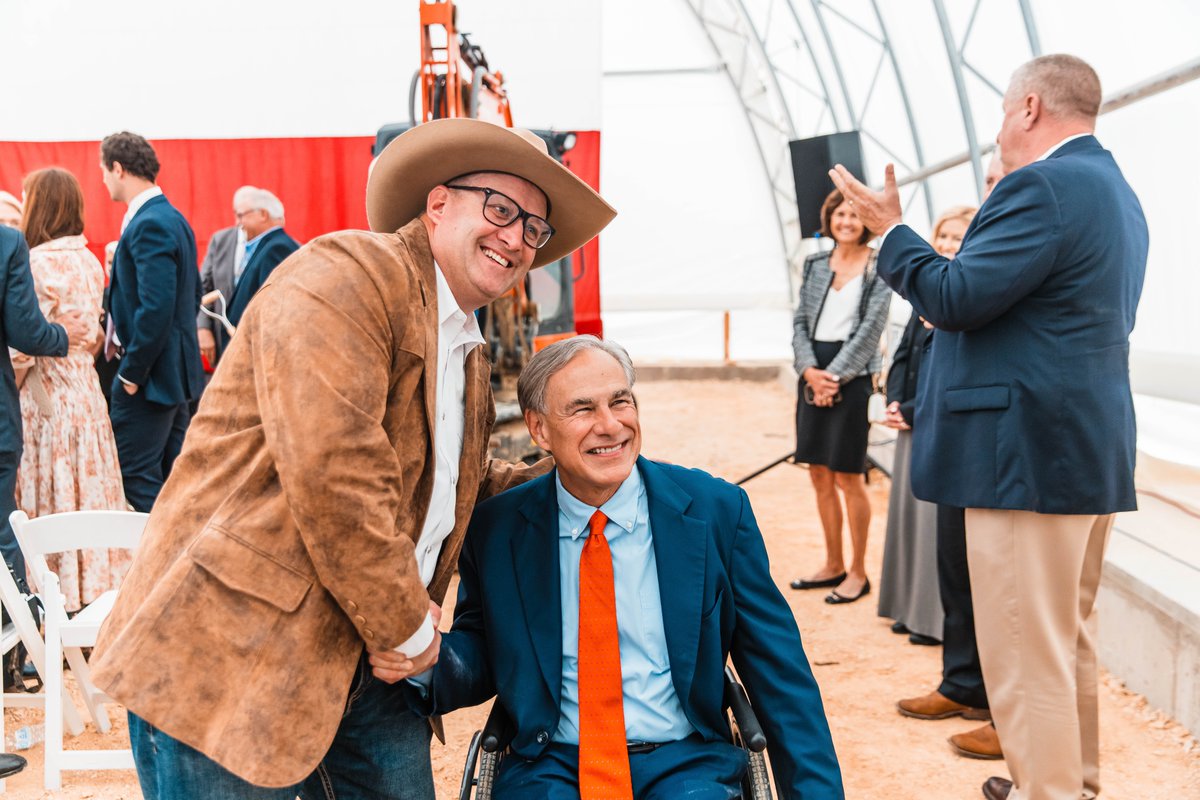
[367,119,617,267]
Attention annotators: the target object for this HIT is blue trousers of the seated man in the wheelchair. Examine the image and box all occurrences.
[492,734,746,800]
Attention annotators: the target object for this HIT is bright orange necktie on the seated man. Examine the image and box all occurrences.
[578,511,634,800]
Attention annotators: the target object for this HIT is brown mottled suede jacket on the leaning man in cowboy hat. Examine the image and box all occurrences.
[92,219,548,787]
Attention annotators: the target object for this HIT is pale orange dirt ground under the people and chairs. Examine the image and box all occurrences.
[5,381,1200,800]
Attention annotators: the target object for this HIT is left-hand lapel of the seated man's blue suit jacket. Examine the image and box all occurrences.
[512,473,563,709]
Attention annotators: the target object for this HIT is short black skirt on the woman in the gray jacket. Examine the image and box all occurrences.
[796,342,871,473]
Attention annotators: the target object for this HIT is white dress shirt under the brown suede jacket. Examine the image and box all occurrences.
[396,263,484,656]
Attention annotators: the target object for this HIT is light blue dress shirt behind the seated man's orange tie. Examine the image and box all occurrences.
[552,468,695,745]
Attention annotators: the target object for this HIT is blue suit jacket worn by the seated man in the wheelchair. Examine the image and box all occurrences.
[433,458,844,800]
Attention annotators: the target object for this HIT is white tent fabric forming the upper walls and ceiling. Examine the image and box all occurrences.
[0,0,1200,379]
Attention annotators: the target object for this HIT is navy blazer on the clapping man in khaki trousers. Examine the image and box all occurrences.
[878,136,1148,513]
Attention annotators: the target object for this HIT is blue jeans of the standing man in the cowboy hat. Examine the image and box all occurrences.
[130,658,433,800]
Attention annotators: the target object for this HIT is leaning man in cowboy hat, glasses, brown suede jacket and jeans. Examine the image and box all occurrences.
[94,120,616,800]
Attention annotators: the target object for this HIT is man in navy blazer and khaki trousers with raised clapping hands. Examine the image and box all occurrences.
[834,55,1148,800]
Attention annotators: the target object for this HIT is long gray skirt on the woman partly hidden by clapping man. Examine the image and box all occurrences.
[880,431,944,639]
